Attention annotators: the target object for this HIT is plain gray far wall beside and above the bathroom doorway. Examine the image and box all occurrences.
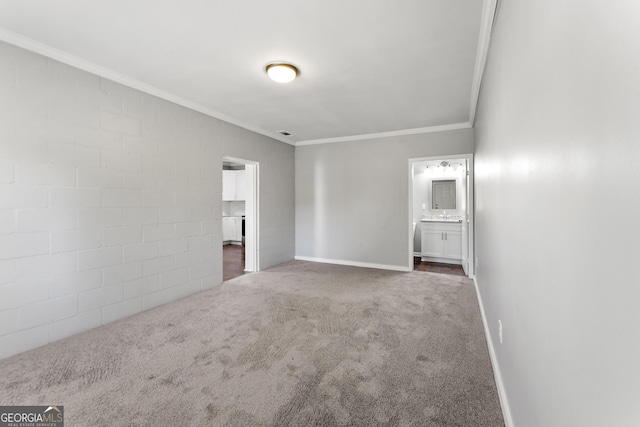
[295,129,473,269]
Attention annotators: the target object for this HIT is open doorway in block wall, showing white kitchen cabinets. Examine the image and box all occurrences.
[222,156,259,281]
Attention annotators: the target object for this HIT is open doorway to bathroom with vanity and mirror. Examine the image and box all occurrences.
[409,154,474,277]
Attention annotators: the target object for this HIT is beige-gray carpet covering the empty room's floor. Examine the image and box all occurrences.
[0,261,504,427]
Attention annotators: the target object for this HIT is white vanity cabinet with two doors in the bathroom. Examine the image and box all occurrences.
[420,221,462,264]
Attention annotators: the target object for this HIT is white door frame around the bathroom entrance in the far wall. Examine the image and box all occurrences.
[407,153,476,278]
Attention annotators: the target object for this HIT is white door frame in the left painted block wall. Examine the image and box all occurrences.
[221,155,260,272]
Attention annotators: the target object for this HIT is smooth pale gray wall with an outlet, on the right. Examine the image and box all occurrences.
[475,0,640,427]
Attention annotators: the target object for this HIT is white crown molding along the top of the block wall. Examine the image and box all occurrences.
[0,27,295,145]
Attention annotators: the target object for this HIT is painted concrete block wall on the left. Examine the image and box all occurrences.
[0,43,294,357]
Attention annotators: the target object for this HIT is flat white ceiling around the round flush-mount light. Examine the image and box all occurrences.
[0,0,495,145]
